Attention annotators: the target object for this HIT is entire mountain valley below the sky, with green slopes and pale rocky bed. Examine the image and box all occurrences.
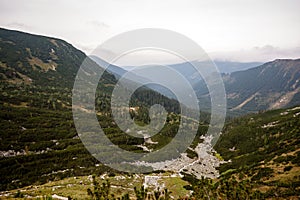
[0,29,300,200]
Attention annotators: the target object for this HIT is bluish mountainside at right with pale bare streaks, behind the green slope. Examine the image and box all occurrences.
[224,59,300,111]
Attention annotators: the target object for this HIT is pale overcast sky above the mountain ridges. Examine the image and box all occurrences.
[0,0,300,65]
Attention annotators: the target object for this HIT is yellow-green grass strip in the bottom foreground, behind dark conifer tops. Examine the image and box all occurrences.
[1,173,189,200]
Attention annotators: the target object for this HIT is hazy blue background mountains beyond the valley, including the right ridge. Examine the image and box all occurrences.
[89,54,300,115]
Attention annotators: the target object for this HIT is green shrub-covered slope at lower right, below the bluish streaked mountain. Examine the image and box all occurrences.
[215,106,300,199]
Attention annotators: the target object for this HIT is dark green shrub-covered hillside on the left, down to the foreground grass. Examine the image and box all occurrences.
[0,29,185,190]
